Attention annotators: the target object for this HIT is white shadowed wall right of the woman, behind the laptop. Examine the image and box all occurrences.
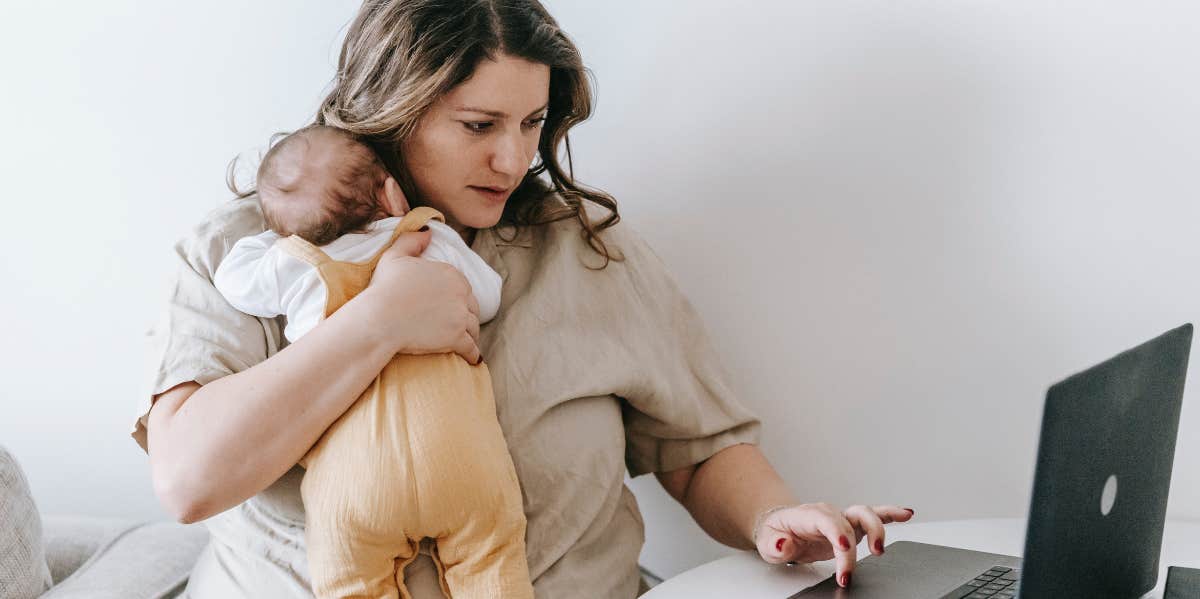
[554,1,1200,574]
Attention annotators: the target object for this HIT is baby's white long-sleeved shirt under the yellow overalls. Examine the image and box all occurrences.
[212,216,502,342]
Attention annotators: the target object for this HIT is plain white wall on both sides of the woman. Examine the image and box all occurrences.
[0,0,1200,583]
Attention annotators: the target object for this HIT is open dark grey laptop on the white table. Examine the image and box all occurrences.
[788,324,1192,599]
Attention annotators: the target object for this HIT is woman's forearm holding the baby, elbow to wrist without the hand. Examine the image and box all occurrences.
[148,291,395,522]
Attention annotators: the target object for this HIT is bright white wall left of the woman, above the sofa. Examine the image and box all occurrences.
[0,0,358,517]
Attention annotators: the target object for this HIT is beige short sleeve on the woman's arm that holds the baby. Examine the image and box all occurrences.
[132,198,282,449]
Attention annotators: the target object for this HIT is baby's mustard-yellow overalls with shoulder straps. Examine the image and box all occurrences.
[280,208,533,599]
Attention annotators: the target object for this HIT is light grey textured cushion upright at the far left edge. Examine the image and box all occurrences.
[0,447,50,599]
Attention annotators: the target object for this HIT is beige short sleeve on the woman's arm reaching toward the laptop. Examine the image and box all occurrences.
[607,220,761,477]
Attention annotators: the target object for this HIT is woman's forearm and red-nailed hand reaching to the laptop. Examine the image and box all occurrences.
[656,444,913,587]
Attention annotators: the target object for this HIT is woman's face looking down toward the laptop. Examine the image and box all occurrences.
[400,54,550,234]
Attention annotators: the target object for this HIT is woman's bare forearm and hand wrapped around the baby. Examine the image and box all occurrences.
[148,234,479,522]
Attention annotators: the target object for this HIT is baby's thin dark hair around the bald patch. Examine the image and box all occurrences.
[227,125,388,245]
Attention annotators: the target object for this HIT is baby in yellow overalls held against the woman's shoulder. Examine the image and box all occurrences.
[214,125,533,599]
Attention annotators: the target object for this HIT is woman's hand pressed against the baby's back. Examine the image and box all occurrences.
[360,229,480,364]
